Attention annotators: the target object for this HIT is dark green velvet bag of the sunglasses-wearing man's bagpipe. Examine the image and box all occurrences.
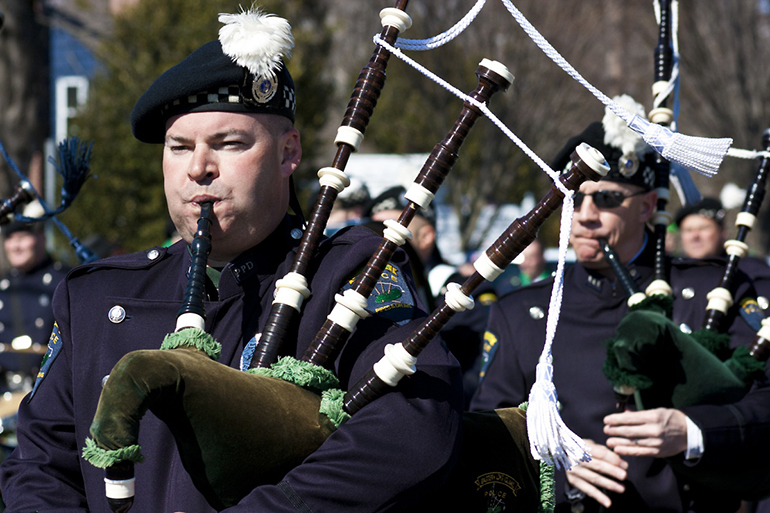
[604,310,751,409]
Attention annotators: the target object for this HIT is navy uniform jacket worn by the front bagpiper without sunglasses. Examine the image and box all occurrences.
[1,225,461,513]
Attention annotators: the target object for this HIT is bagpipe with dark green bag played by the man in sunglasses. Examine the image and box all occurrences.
[602,0,770,408]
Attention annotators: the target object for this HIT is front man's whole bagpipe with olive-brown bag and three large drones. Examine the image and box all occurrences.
[78,1,609,512]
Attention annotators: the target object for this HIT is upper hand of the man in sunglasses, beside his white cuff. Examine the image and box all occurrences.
[604,408,687,458]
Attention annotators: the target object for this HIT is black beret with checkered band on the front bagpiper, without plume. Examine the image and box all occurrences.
[131,40,296,143]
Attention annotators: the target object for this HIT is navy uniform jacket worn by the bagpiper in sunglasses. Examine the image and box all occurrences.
[471,240,770,512]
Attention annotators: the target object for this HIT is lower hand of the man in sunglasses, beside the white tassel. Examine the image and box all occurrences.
[567,440,628,508]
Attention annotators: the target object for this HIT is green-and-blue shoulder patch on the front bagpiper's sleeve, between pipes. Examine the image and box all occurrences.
[343,263,414,325]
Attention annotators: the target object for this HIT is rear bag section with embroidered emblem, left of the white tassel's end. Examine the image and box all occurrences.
[425,408,553,513]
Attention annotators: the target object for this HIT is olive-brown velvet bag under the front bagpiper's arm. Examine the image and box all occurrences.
[86,347,335,510]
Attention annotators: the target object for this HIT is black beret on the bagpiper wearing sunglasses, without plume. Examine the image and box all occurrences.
[551,121,655,191]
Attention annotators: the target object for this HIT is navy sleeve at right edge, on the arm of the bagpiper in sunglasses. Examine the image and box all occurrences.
[674,268,770,499]
